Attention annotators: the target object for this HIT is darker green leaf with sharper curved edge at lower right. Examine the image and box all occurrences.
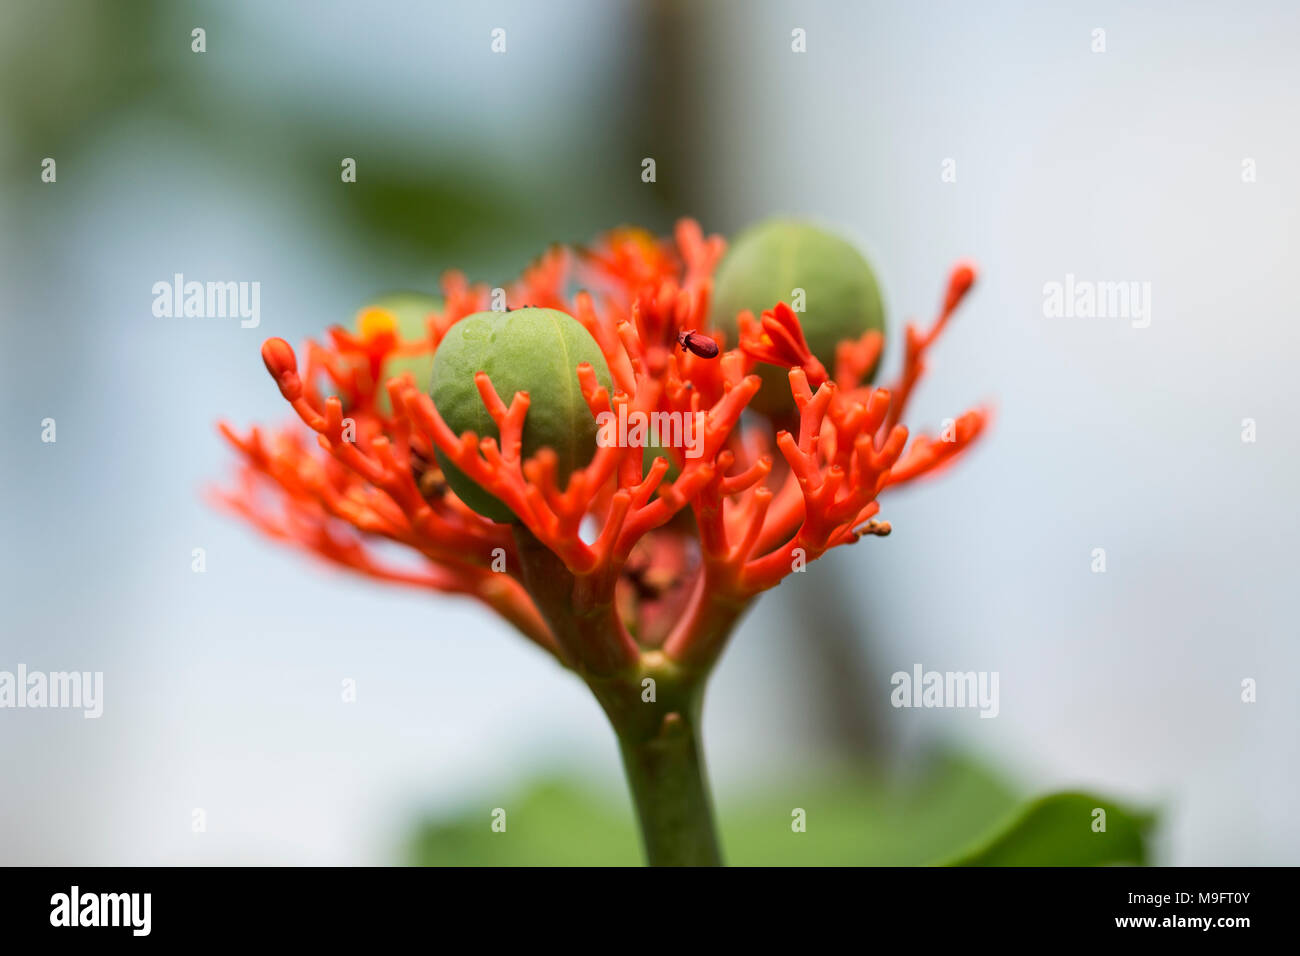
[950,793,1154,866]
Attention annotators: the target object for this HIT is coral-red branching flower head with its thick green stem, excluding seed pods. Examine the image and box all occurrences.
[218,220,987,862]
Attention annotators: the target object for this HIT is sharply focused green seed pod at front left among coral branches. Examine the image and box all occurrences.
[432,308,614,522]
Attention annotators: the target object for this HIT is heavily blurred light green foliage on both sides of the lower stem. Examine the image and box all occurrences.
[408,754,1015,866]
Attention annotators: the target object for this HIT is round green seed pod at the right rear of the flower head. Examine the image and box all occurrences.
[711,220,885,416]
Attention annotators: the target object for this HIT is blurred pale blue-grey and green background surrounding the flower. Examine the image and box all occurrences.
[0,0,1300,864]
